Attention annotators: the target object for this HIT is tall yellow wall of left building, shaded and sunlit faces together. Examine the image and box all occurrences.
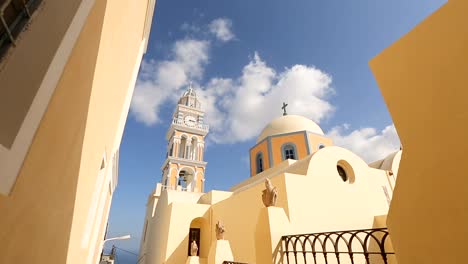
[0,0,152,264]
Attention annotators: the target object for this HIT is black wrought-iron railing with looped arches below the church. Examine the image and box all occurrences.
[281,228,396,264]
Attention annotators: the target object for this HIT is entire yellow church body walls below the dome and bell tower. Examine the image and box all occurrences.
[146,146,390,264]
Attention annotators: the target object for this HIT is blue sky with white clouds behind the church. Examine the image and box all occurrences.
[108,0,445,252]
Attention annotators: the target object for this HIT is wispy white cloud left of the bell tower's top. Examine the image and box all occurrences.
[130,39,210,125]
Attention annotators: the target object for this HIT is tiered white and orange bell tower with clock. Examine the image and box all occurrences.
[161,85,209,192]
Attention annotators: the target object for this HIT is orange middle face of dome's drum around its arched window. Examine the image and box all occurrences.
[271,132,308,166]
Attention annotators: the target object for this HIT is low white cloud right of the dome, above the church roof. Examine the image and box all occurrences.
[327,124,400,162]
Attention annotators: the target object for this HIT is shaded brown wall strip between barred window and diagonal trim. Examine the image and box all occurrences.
[0,0,85,148]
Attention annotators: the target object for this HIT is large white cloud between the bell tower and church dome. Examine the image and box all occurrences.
[200,53,334,143]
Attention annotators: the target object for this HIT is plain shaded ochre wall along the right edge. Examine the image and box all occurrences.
[370,0,468,264]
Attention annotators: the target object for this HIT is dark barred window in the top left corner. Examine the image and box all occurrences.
[0,0,41,58]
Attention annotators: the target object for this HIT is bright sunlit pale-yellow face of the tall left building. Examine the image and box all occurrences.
[68,0,149,263]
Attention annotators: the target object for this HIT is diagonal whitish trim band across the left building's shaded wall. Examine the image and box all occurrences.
[0,0,95,195]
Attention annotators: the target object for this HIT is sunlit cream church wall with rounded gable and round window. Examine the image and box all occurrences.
[286,146,390,234]
